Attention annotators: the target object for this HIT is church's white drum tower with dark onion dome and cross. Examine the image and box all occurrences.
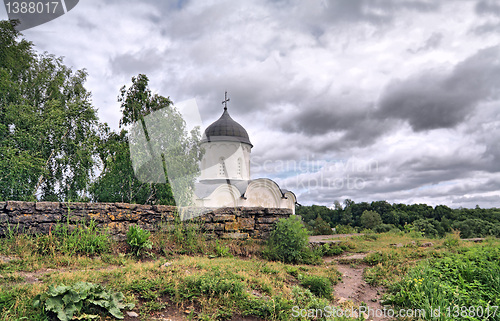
[200,92,253,181]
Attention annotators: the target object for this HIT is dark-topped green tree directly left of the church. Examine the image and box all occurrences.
[92,74,202,206]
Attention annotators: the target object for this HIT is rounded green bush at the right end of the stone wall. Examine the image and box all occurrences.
[263,216,316,264]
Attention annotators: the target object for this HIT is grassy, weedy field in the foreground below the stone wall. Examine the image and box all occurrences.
[0,221,500,320]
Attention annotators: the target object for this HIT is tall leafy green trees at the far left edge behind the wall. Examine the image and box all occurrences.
[0,21,99,201]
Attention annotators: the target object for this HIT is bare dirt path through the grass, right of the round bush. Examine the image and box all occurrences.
[324,253,389,321]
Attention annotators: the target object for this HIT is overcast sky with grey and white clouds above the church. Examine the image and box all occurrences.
[0,0,500,208]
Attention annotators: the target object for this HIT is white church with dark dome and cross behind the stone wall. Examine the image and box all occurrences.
[195,93,297,214]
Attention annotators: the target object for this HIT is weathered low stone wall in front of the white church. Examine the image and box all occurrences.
[0,201,292,239]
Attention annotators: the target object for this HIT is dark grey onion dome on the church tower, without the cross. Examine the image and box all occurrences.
[201,108,253,147]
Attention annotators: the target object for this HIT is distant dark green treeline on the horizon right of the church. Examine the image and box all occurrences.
[296,199,500,238]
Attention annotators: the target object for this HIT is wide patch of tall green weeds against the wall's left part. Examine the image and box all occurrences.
[35,220,111,256]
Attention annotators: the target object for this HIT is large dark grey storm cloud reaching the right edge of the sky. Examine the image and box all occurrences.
[377,46,500,131]
